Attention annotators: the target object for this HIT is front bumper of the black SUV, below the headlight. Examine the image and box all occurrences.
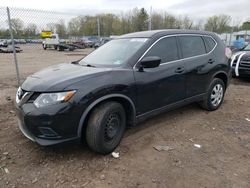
[16,103,80,146]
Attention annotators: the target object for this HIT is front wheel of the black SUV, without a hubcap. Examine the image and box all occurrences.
[85,101,126,154]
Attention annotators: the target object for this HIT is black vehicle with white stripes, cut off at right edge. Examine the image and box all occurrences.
[231,44,250,77]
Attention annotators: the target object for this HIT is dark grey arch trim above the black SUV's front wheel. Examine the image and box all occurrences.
[77,94,136,138]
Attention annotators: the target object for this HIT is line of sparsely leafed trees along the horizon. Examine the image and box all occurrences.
[0,8,250,38]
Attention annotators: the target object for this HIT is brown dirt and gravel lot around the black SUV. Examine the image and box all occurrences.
[0,45,250,188]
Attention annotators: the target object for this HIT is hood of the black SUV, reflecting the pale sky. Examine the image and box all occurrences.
[21,64,111,92]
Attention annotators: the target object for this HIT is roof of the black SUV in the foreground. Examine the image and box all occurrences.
[118,29,215,38]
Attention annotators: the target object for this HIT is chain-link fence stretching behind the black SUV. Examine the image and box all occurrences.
[0,7,249,85]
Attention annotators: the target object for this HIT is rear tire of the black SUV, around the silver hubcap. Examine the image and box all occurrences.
[199,78,226,111]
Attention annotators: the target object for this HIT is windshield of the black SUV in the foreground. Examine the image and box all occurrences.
[79,38,147,66]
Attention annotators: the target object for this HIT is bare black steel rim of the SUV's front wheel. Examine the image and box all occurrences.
[105,113,121,142]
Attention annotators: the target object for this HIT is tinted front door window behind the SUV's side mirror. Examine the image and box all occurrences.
[145,37,179,63]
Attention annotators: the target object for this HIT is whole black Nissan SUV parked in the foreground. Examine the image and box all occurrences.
[16,30,231,154]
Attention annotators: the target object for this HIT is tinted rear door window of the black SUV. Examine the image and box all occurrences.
[179,36,206,58]
